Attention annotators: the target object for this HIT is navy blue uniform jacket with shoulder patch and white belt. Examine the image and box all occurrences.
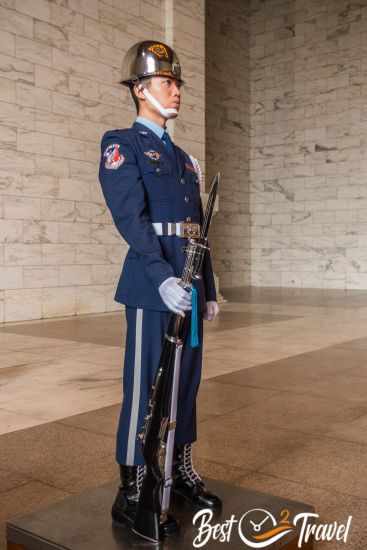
[99,122,216,311]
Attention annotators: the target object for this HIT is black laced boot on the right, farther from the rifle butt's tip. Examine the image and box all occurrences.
[172,443,222,510]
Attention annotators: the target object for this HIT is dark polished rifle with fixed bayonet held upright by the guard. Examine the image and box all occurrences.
[132,172,220,542]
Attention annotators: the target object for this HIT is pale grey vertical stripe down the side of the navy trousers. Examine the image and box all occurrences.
[126,308,143,466]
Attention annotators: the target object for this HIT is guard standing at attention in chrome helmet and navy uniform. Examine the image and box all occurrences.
[99,41,221,523]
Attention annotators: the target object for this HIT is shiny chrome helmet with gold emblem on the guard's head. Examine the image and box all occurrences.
[120,40,183,87]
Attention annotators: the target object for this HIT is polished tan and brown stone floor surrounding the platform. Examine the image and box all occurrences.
[0,288,367,550]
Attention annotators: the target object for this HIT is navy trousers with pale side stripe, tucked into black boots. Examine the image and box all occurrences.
[116,306,203,466]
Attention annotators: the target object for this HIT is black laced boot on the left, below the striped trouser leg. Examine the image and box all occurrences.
[111,464,145,523]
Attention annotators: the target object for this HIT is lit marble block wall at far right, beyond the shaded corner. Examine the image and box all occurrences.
[250,0,367,289]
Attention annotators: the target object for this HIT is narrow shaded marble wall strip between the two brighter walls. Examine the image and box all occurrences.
[205,0,250,287]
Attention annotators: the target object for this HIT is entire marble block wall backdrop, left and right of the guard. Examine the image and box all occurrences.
[6,0,367,322]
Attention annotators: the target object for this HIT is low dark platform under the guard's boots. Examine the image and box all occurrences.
[7,480,315,550]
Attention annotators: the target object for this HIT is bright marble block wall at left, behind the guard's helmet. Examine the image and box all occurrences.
[0,0,205,322]
